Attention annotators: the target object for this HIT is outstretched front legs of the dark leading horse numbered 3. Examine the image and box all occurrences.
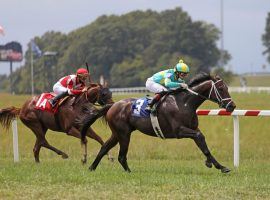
[179,127,230,173]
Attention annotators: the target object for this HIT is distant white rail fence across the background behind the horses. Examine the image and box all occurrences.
[110,87,270,94]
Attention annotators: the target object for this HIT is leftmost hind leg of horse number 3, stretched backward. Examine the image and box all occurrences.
[89,134,118,171]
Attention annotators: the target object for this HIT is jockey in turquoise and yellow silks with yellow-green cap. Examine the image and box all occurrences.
[145,60,189,111]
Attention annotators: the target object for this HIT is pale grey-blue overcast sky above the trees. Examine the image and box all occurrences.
[0,0,270,74]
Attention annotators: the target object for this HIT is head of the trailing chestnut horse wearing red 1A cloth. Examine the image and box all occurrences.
[86,84,113,106]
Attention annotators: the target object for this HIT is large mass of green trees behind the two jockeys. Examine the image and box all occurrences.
[0,7,234,93]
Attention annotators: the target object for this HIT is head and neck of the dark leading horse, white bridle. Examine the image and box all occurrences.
[189,73,236,112]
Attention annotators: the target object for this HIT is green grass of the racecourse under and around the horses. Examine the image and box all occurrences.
[0,93,270,199]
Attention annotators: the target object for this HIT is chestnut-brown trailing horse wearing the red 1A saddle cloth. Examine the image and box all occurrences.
[0,84,113,163]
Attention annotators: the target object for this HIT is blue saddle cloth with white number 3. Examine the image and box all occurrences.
[132,97,151,118]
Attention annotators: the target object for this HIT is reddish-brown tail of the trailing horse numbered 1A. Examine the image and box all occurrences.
[0,106,21,130]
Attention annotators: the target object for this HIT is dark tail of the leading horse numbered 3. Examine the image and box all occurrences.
[81,104,113,143]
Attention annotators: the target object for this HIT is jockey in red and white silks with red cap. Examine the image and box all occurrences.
[49,68,89,107]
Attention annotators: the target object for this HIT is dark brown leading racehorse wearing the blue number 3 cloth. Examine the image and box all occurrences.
[81,73,236,173]
